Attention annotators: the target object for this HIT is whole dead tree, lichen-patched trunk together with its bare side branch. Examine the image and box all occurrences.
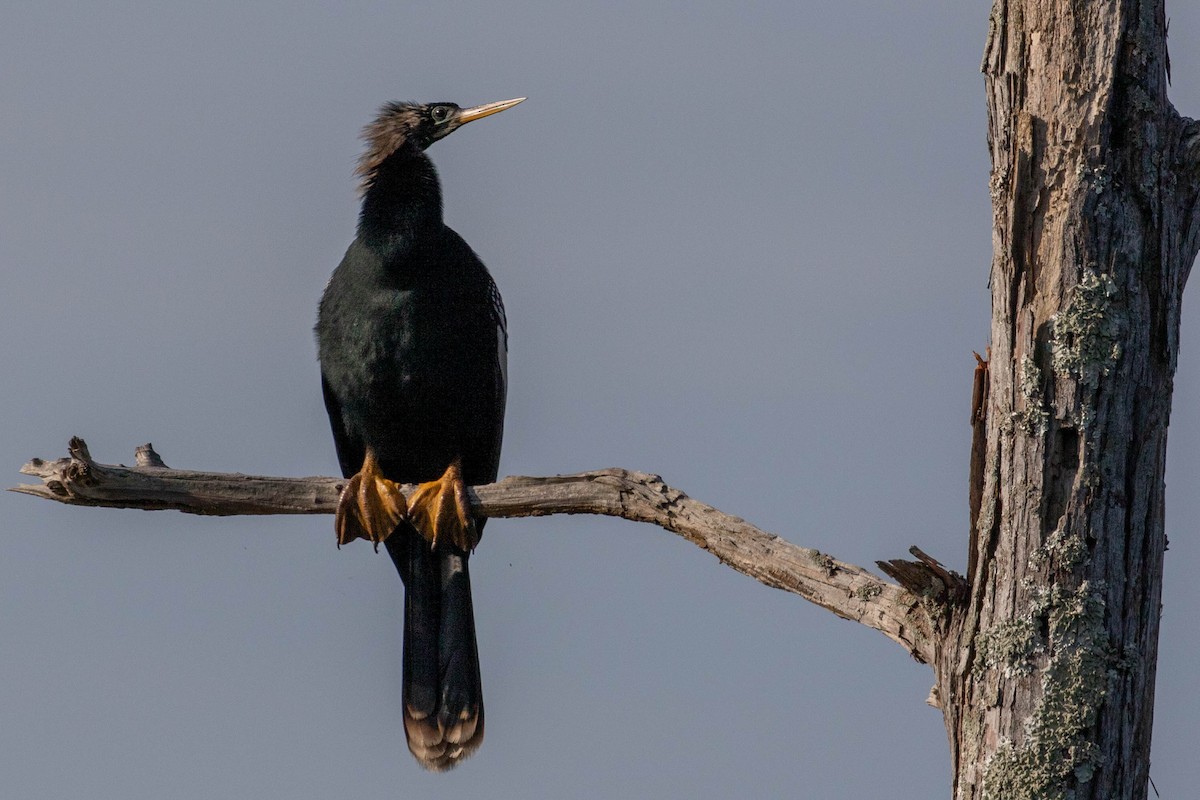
[9,0,1200,800]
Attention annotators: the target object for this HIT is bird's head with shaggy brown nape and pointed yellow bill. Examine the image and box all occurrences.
[355,97,524,188]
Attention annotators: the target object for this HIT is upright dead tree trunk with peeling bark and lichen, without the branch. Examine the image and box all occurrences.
[935,0,1198,800]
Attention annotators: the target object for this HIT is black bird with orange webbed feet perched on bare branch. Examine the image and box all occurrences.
[317,97,524,770]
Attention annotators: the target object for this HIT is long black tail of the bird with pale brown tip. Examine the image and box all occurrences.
[388,532,484,771]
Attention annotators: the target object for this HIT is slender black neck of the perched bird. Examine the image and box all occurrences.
[359,144,443,260]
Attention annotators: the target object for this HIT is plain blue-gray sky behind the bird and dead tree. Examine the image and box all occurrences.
[0,0,1200,799]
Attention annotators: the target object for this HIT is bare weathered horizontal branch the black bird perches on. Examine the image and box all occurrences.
[10,438,940,663]
